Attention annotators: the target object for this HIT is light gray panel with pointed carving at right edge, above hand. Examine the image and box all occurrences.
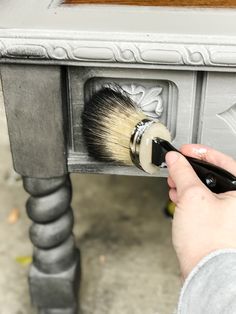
[198,72,236,158]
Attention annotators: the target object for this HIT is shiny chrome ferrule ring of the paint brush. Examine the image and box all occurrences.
[129,119,156,170]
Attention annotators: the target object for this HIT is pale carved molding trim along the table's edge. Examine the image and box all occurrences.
[0,31,236,67]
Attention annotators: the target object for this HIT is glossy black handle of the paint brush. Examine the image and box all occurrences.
[152,138,236,193]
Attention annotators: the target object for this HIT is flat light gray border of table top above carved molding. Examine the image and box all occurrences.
[0,0,236,36]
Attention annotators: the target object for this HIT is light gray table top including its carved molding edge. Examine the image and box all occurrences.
[0,0,236,70]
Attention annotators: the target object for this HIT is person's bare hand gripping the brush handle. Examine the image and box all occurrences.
[166,144,236,279]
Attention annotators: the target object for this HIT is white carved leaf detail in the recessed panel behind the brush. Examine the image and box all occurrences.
[122,84,164,118]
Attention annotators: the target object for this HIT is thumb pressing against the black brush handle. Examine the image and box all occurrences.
[166,151,205,195]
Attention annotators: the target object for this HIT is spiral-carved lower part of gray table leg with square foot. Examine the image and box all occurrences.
[23,176,80,314]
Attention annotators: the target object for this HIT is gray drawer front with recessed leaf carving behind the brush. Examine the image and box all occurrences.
[68,67,197,176]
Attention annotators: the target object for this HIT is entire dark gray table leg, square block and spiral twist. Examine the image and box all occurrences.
[0,64,80,314]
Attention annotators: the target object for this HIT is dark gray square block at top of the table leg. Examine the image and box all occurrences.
[1,65,67,178]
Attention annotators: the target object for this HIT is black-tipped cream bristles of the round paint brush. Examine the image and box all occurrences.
[82,87,169,165]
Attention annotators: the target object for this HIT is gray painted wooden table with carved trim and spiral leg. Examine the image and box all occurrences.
[0,0,236,314]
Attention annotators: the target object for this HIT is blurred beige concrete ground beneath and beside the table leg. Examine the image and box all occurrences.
[0,83,180,314]
